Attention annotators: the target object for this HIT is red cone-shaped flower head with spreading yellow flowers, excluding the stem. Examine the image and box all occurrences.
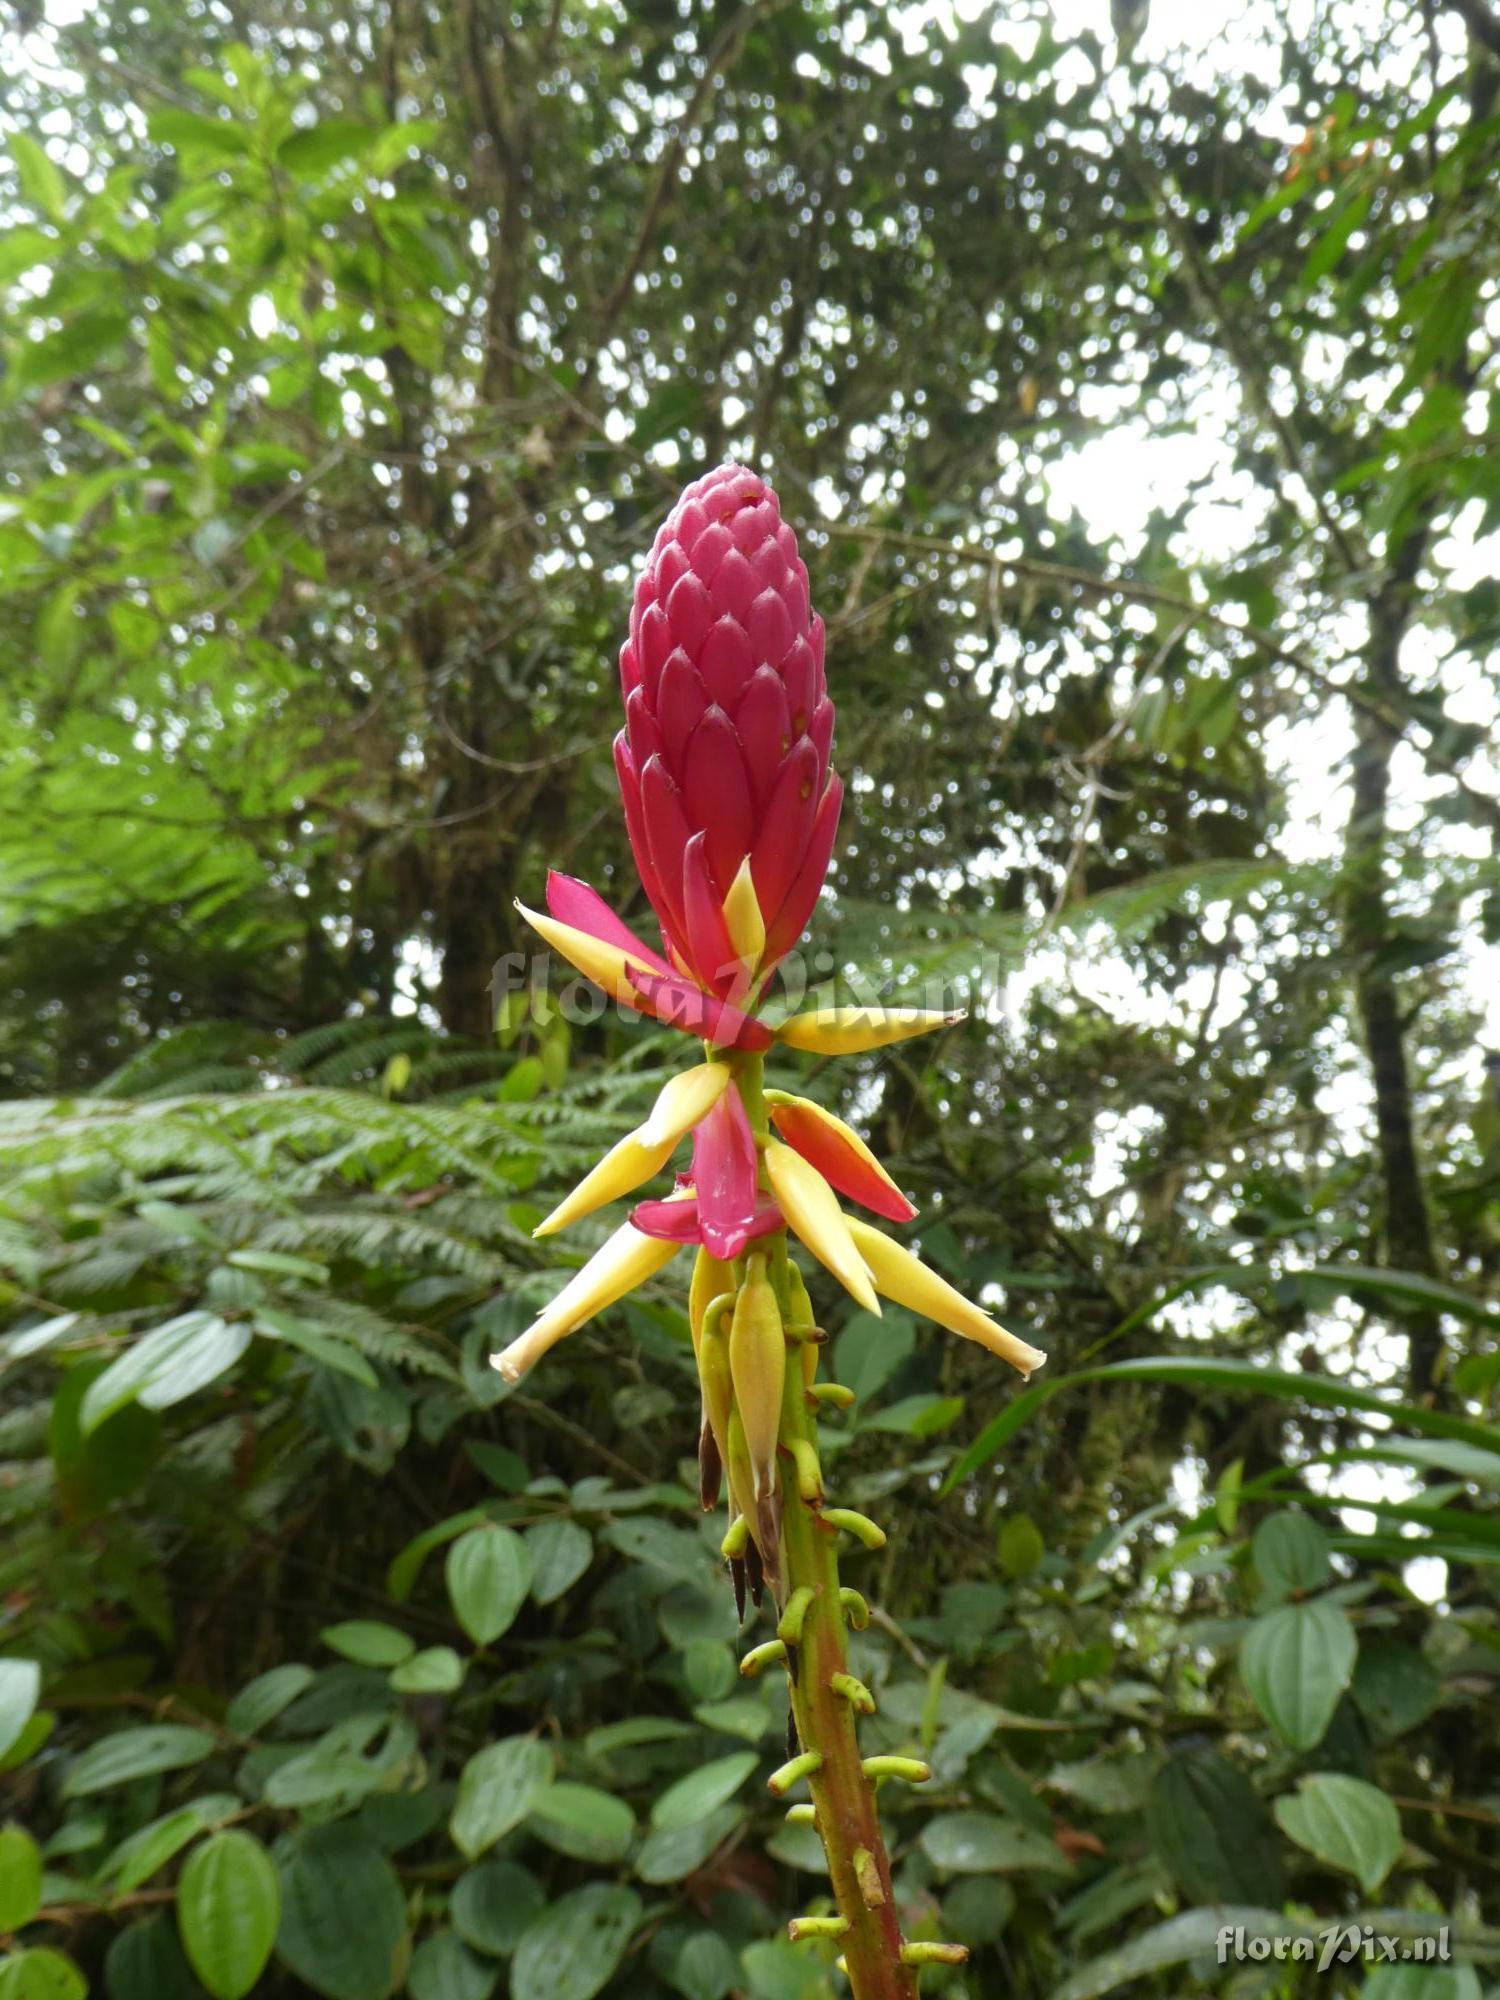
[496,466,1042,1408]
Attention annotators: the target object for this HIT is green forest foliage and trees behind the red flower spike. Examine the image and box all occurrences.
[0,0,1500,2000]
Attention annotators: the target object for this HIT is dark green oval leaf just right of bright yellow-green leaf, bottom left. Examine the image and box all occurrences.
[276,1820,406,2000]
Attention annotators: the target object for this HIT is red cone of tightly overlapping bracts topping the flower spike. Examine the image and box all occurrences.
[614,466,844,998]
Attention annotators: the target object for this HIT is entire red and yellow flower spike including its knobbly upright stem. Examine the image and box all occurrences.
[496,466,1042,2000]
